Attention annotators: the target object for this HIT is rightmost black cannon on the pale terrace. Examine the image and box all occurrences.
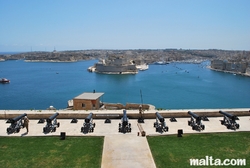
[219,111,240,130]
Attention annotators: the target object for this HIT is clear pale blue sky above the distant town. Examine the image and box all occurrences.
[0,0,250,52]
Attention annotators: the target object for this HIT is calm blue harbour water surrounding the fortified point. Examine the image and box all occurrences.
[0,60,250,110]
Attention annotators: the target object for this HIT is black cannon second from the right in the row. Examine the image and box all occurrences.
[188,111,205,131]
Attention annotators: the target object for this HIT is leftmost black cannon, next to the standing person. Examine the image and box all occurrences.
[7,113,27,134]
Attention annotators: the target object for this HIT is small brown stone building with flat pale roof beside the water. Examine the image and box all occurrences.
[73,92,104,110]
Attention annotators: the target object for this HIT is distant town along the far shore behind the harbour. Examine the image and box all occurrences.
[0,49,250,75]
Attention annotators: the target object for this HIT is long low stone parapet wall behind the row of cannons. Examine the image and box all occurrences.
[0,108,250,119]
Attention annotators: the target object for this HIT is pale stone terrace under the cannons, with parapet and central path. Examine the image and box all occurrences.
[0,109,250,168]
